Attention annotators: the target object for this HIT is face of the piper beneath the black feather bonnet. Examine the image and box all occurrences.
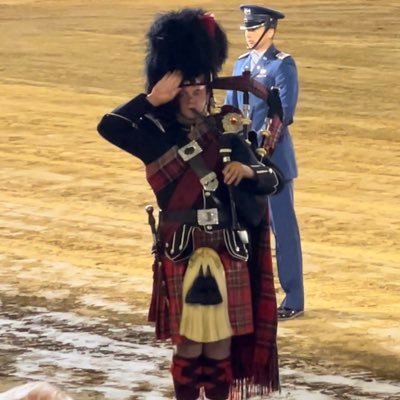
[178,79,208,119]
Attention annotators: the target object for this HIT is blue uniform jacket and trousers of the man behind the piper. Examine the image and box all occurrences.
[226,45,304,311]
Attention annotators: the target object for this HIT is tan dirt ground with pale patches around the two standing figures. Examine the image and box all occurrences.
[0,0,400,400]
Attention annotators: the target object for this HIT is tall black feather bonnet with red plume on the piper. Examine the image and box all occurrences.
[145,8,228,91]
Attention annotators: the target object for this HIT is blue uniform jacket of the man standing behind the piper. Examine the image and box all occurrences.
[226,45,298,180]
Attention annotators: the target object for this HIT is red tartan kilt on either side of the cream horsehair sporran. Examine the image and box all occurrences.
[155,249,254,344]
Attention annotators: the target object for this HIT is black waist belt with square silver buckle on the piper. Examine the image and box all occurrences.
[160,208,231,226]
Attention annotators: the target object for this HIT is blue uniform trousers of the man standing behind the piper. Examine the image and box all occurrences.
[269,180,304,310]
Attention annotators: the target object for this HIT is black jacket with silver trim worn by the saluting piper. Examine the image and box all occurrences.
[98,94,283,225]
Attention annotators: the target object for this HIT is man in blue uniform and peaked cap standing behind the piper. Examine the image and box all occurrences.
[226,5,304,320]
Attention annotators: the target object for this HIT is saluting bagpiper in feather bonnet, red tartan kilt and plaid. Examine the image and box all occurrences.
[98,8,282,400]
